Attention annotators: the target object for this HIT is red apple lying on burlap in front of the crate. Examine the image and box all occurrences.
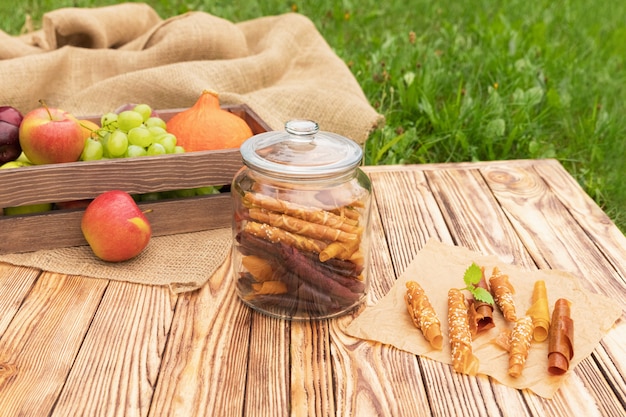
[80,190,152,262]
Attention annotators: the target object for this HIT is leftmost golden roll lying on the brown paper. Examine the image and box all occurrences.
[404,281,443,350]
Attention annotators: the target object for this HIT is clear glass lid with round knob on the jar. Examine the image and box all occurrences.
[240,120,363,179]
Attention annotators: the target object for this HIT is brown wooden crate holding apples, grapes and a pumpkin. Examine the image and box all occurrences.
[0,105,270,253]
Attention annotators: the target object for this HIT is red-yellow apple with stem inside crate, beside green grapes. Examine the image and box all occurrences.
[20,105,85,165]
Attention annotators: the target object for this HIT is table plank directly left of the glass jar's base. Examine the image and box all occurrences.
[148,255,251,417]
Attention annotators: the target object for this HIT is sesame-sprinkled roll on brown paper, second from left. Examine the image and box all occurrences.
[448,288,478,375]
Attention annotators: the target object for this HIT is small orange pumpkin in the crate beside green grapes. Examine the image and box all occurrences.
[167,90,252,152]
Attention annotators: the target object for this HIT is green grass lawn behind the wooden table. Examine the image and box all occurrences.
[0,0,626,230]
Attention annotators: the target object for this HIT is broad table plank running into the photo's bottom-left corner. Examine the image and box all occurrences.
[0,273,108,416]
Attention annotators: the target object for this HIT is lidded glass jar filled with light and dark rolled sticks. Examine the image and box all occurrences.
[231,120,371,320]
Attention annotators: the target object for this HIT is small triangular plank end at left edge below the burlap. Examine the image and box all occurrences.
[0,262,41,337]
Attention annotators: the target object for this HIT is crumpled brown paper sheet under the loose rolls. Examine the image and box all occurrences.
[346,240,622,398]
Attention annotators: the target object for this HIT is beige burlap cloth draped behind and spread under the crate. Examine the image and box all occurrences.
[0,3,382,292]
